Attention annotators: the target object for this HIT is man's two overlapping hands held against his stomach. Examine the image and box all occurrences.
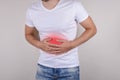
[40,38,74,55]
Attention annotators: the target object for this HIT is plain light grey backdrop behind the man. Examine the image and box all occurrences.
[0,0,120,80]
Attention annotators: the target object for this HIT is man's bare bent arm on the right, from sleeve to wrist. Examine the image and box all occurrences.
[73,17,97,47]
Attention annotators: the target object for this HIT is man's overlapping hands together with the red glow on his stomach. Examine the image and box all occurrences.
[42,34,73,55]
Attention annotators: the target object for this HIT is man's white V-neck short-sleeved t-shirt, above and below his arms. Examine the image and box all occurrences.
[26,0,88,68]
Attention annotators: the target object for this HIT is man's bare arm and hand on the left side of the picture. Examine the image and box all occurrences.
[25,25,57,53]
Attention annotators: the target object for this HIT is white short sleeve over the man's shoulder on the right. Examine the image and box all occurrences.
[74,0,88,23]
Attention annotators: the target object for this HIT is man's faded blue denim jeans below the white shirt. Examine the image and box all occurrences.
[36,64,80,80]
